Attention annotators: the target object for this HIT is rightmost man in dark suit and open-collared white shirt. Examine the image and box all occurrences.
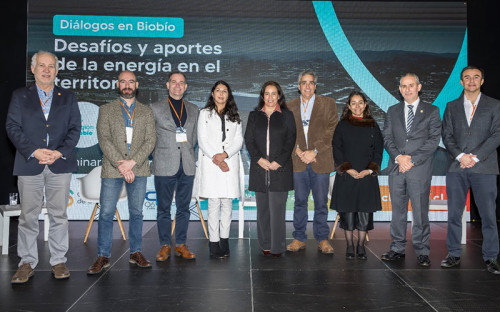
[441,66,500,274]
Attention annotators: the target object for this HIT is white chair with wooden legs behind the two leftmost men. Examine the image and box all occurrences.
[78,166,127,243]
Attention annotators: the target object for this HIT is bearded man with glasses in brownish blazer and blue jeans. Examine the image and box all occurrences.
[87,71,156,274]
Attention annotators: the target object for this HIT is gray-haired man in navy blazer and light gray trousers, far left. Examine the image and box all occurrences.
[6,51,81,284]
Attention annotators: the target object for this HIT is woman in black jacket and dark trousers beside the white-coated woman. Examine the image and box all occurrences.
[245,81,296,257]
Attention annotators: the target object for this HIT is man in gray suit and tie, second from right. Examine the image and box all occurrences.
[382,73,441,266]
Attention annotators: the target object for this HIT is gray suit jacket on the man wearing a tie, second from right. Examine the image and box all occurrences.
[382,101,441,179]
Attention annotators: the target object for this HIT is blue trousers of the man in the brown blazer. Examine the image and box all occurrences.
[293,164,330,242]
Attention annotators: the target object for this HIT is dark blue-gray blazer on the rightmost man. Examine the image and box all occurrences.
[443,94,500,174]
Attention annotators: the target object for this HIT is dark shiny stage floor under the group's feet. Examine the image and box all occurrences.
[0,220,500,312]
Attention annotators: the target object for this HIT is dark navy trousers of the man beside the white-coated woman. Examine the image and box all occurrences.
[155,163,194,246]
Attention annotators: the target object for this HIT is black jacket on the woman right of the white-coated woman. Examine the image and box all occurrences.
[245,108,297,192]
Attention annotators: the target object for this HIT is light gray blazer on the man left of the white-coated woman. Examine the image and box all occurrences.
[151,98,198,176]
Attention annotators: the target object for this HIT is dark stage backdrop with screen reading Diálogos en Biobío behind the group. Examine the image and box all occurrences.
[0,0,500,219]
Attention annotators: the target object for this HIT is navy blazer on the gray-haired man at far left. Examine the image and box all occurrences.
[5,85,81,176]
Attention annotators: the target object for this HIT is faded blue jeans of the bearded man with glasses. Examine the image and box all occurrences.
[97,176,147,257]
